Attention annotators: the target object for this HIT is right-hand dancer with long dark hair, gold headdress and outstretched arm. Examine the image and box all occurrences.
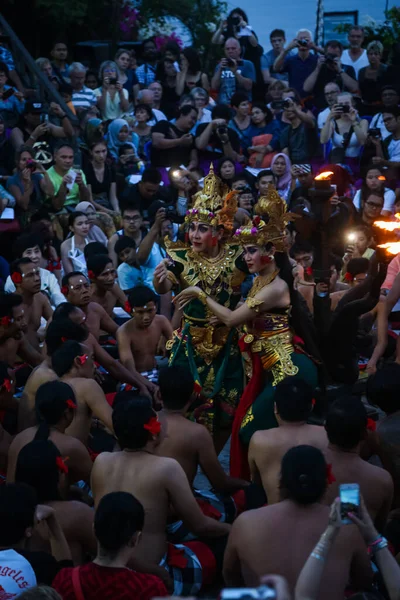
[175,186,318,478]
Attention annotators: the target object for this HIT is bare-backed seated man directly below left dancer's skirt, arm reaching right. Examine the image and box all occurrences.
[155,366,253,542]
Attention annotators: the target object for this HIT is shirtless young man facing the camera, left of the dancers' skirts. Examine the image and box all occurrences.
[117,285,173,383]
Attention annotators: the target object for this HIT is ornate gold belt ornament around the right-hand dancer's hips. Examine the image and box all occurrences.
[244,329,299,386]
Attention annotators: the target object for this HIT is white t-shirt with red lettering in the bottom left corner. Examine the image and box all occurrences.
[0,550,36,598]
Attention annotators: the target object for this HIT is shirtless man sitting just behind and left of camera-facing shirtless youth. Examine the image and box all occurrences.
[87,254,127,318]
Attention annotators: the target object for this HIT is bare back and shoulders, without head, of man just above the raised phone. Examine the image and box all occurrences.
[323,443,393,531]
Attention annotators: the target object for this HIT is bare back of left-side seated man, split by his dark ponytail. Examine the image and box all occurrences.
[7,408,93,484]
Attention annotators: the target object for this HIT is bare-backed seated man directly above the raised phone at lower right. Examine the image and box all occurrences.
[324,396,393,531]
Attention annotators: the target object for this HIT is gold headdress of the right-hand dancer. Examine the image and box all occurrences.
[234,184,292,252]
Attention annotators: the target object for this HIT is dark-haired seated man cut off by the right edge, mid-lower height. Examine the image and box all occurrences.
[367,363,400,508]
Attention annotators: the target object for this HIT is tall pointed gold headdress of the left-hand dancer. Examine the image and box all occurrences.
[185,164,237,233]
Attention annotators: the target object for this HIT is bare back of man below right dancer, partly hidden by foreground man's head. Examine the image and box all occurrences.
[249,405,328,505]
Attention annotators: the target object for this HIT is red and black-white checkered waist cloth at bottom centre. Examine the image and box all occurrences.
[160,542,216,596]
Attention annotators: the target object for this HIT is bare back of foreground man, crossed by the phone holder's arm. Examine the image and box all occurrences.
[223,500,372,600]
